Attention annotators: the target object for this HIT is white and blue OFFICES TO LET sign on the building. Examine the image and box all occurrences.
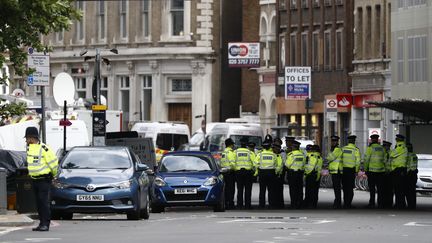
[285,67,311,100]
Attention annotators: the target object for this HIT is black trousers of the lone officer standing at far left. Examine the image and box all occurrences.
[32,178,51,227]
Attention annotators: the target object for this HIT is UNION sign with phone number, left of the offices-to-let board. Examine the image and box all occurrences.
[228,42,260,67]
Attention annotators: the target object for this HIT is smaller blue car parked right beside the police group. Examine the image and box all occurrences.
[151,151,225,213]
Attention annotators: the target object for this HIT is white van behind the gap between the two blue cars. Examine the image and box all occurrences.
[131,122,190,152]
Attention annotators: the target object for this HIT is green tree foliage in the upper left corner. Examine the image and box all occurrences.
[0,0,81,121]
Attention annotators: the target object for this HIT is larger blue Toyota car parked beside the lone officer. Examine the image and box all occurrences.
[51,146,153,220]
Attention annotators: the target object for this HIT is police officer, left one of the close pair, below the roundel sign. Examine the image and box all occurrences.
[327,136,342,209]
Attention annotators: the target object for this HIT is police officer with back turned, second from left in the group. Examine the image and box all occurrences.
[234,137,255,209]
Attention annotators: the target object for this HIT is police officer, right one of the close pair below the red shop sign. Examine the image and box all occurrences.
[342,135,361,208]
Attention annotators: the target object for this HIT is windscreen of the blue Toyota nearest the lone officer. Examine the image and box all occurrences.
[61,149,132,169]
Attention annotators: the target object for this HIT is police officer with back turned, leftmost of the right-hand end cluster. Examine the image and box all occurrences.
[364,134,386,208]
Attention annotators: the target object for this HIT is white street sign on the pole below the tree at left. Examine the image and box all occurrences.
[27,48,50,86]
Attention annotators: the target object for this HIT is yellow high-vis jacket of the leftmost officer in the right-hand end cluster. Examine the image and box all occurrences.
[364,143,385,172]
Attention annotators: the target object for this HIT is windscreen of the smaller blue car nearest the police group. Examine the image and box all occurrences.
[159,155,213,172]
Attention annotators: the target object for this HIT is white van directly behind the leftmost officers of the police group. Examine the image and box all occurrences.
[206,123,264,152]
